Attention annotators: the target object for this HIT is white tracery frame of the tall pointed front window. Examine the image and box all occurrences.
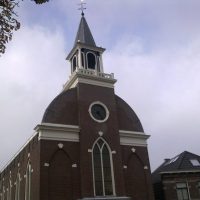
[92,137,116,196]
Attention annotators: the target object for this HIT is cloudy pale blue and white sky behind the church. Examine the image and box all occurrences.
[0,0,200,172]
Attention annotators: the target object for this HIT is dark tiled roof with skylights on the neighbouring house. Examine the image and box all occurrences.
[152,151,200,183]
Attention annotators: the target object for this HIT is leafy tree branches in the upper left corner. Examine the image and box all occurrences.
[0,0,49,56]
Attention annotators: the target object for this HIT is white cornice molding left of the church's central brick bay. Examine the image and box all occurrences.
[35,123,80,142]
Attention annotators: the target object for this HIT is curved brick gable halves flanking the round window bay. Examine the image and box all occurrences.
[42,88,144,132]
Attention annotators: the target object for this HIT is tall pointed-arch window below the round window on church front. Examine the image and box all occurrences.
[92,138,115,196]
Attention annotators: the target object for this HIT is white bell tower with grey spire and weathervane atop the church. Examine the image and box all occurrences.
[63,9,116,90]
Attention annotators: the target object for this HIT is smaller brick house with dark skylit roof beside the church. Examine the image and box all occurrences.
[152,151,200,200]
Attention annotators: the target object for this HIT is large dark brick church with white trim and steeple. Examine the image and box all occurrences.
[0,10,154,200]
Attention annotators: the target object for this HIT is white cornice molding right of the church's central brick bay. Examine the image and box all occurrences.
[119,130,150,147]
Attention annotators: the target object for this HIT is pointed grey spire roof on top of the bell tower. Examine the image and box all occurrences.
[74,15,96,47]
